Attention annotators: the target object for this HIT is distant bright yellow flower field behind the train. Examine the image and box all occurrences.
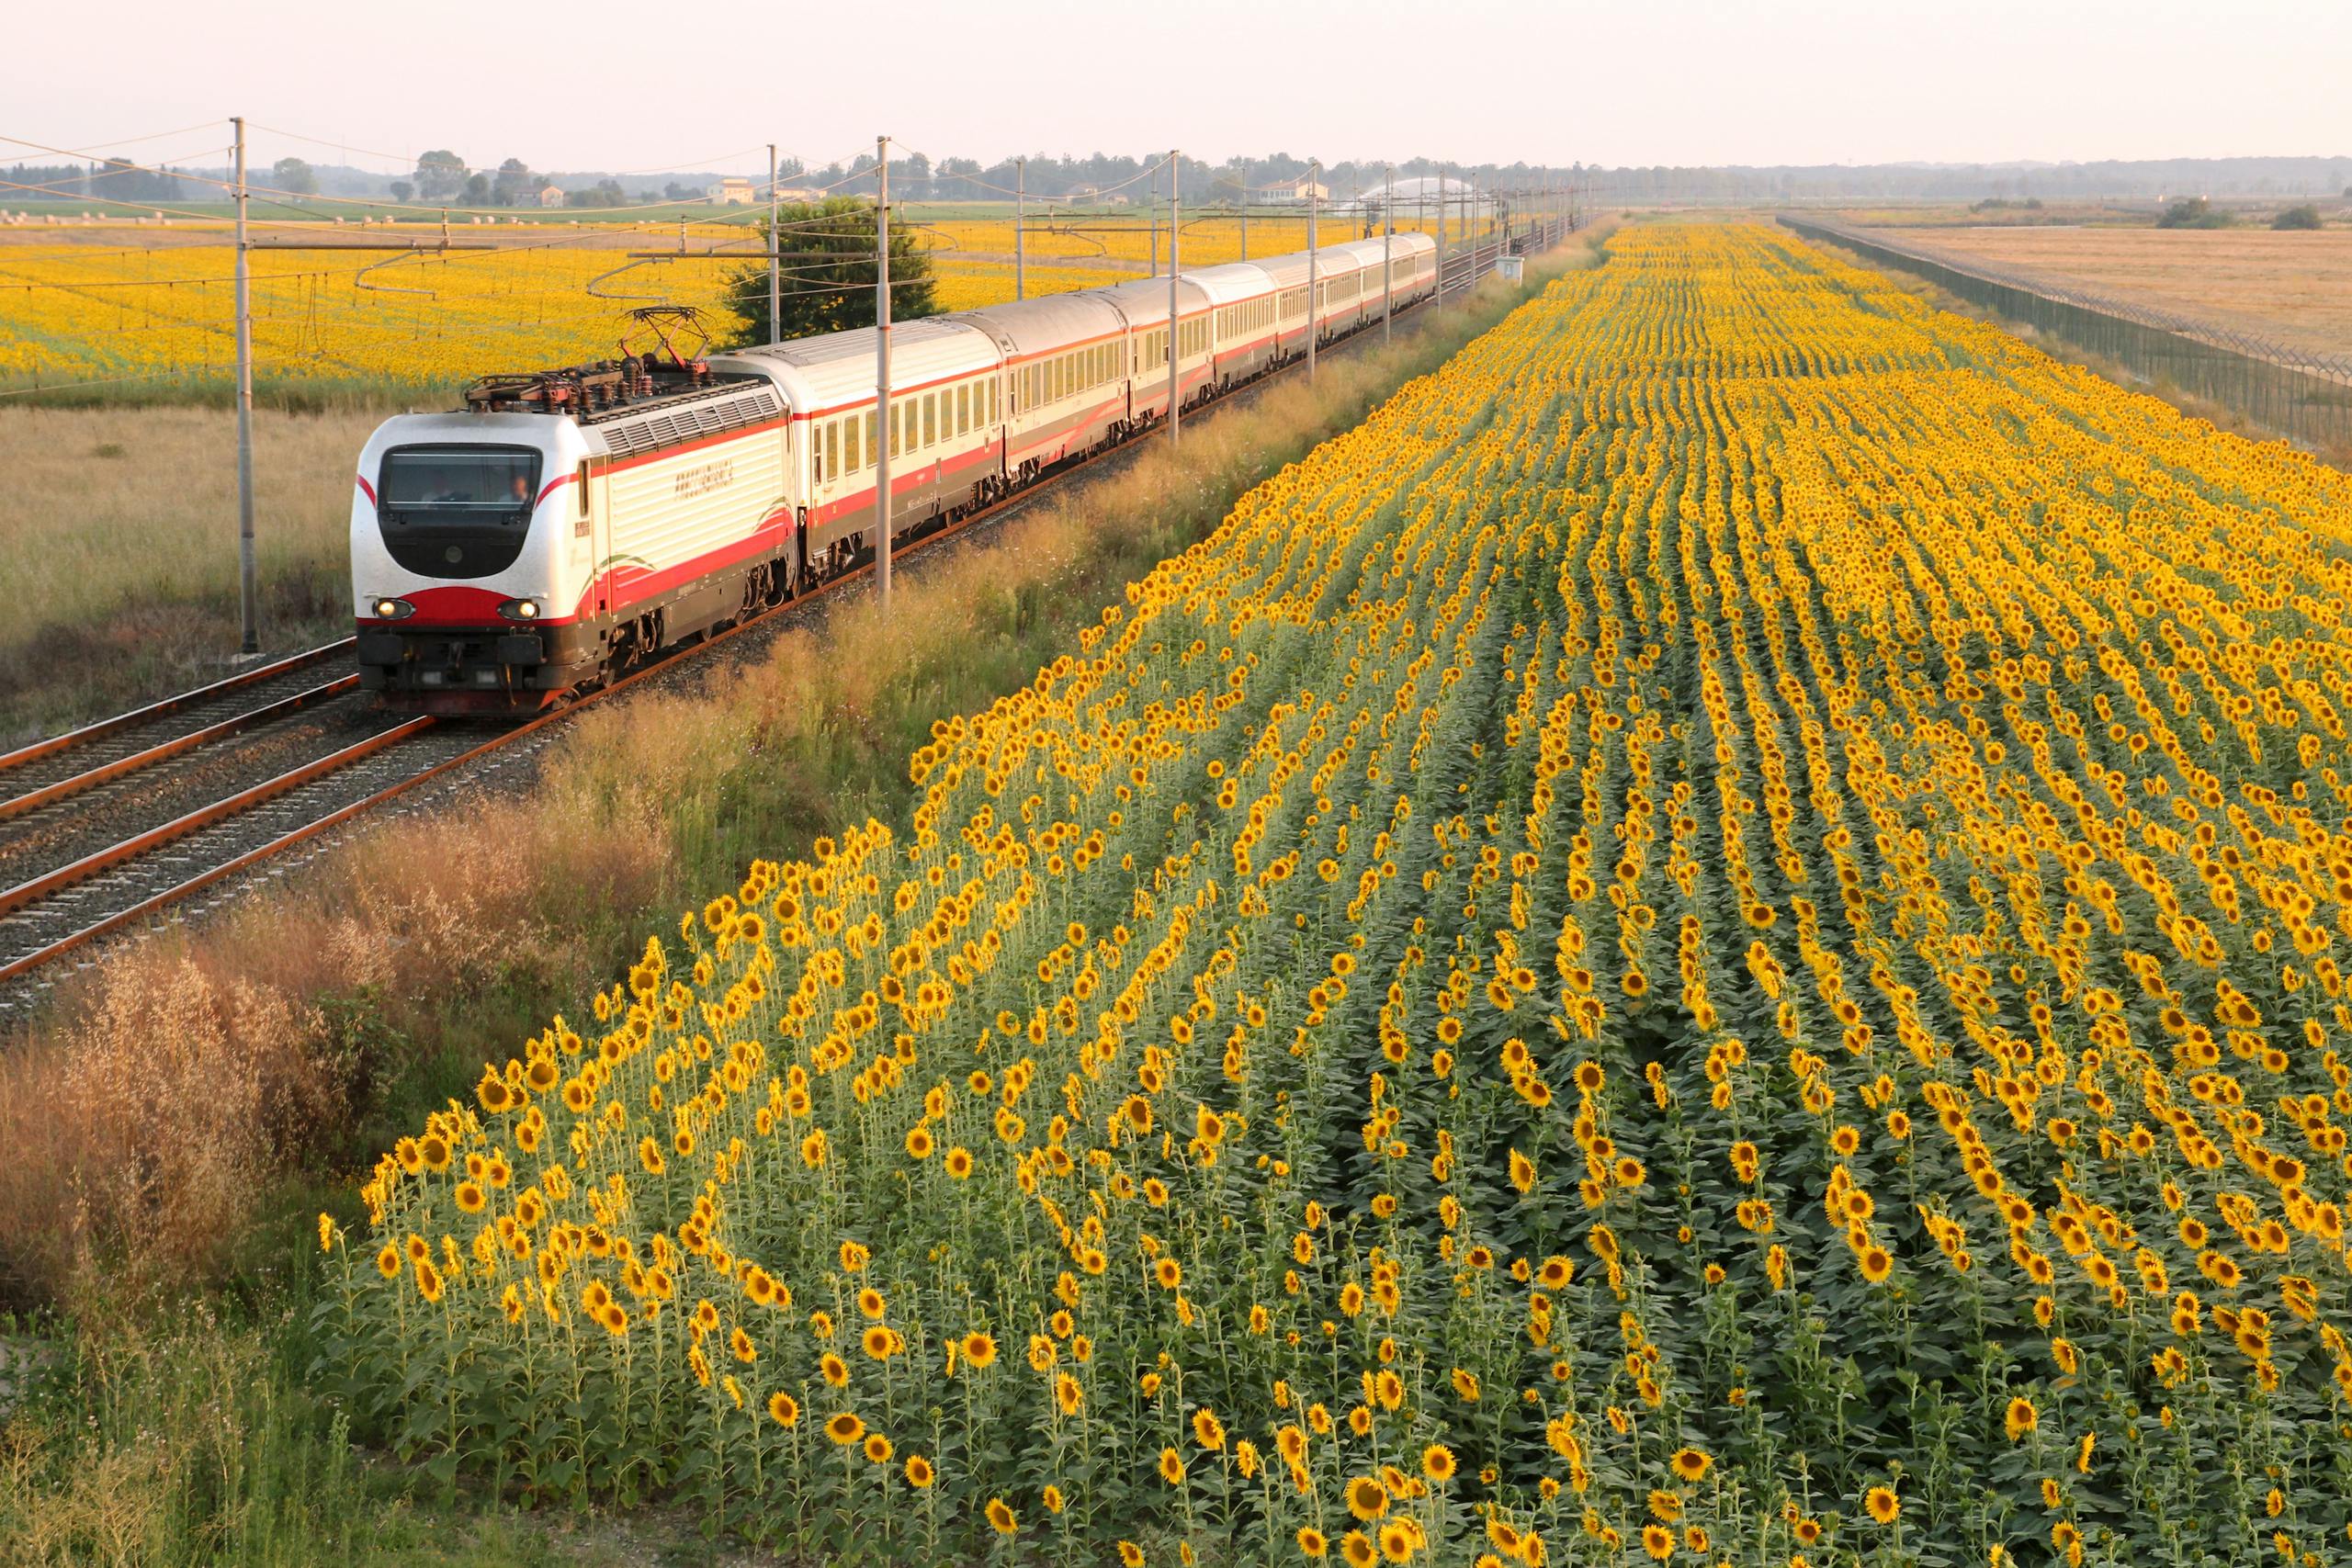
[0,214,1461,398]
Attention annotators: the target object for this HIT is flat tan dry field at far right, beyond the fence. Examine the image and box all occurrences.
[1900,228,2352,353]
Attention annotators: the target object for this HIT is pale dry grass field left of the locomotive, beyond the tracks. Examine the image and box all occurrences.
[0,404,381,748]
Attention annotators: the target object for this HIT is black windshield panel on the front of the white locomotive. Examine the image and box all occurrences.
[377,446,538,579]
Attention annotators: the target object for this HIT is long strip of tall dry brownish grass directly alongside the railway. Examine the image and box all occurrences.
[0,252,1580,1307]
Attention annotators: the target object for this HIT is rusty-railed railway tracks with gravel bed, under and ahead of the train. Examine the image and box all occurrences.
[0,256,1552,1013]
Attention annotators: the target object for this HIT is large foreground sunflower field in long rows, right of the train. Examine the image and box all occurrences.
[318,223,2352,1568]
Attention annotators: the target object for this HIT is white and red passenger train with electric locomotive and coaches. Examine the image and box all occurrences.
[350,232,1437,715]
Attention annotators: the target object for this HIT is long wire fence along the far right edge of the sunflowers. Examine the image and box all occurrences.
[1781,211,2352,449]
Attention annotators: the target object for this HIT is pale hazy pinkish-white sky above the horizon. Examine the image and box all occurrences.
[0,0,2352,174]
